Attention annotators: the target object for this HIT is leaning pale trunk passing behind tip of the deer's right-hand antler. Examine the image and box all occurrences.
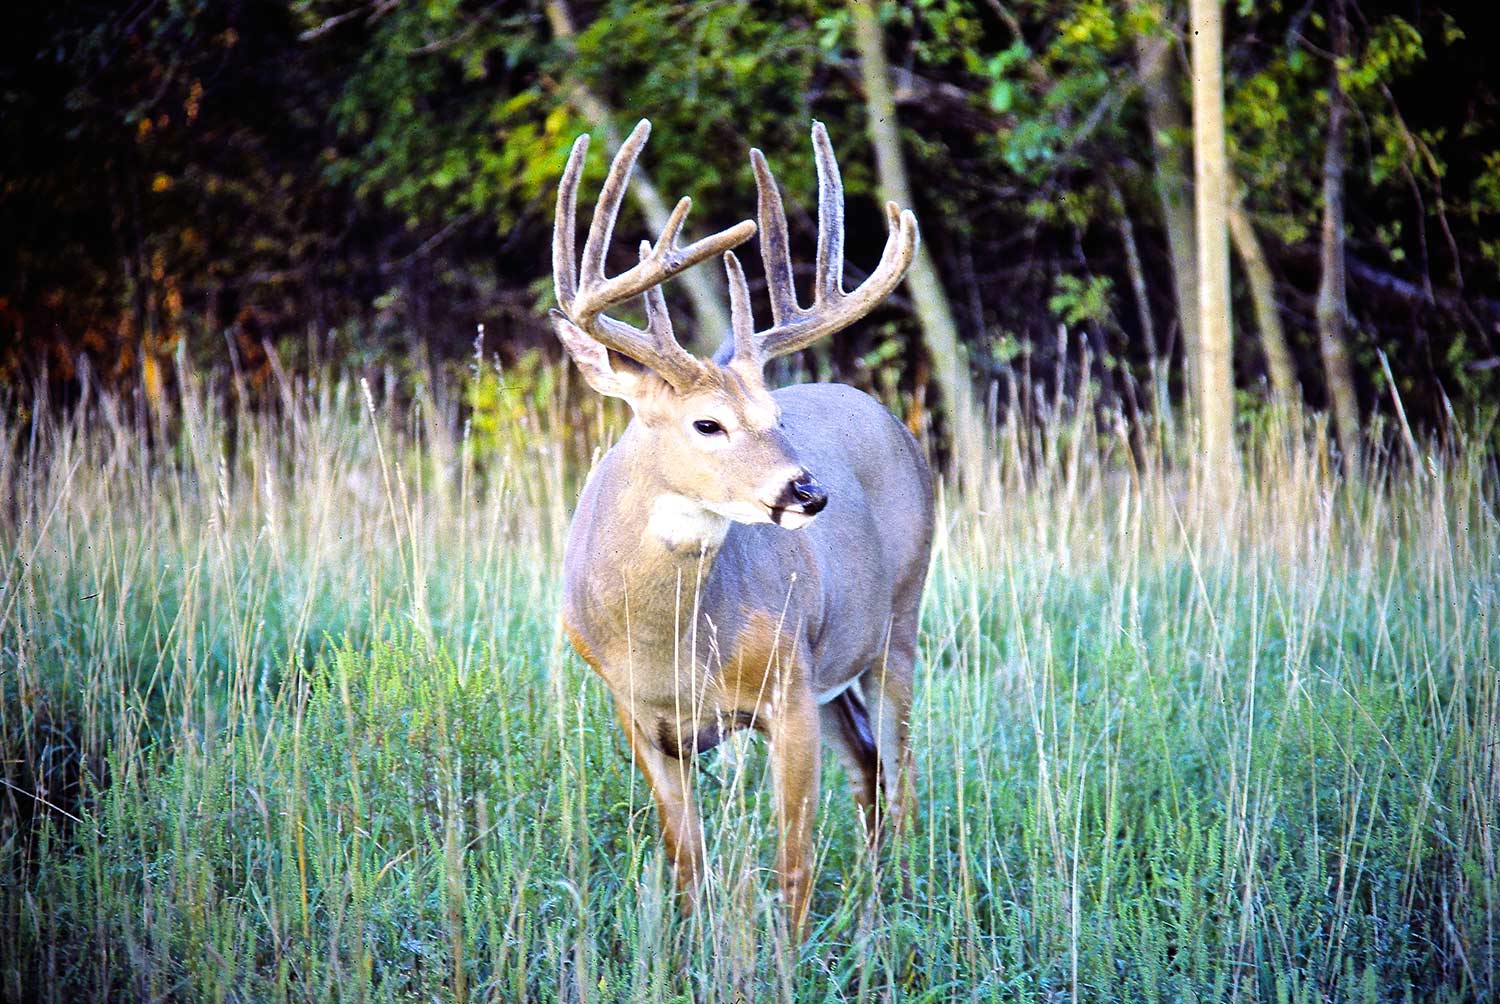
[849,0,984,479]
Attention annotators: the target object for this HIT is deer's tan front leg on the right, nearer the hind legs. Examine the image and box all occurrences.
[768,684,822,941]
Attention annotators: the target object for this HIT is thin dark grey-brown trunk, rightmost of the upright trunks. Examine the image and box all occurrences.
[1317,0,1361,468]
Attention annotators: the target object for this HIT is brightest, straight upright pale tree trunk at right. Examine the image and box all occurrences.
[1190,0,1235,483]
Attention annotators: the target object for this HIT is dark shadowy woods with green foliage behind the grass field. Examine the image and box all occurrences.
[0,0,1500,441]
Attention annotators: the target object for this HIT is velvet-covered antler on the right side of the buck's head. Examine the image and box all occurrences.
[717,122,918,369]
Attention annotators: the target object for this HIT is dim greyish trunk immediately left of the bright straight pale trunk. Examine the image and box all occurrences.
[1136,8,1199,395]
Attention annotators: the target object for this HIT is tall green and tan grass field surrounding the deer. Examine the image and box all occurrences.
[0,367,1500,1001]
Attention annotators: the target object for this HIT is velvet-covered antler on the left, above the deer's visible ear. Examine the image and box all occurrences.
[552,119,756,387]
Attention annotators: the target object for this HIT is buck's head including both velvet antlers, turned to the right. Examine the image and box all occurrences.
[551,119,918,528]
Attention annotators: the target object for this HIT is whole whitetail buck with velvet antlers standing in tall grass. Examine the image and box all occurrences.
[552,122,933,936]
